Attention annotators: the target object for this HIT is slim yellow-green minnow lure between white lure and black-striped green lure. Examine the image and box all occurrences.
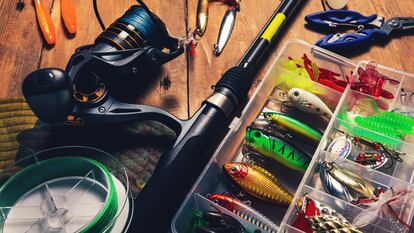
[263,112,323,143]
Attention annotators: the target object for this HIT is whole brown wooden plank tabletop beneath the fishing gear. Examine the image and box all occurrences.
[0,0,414,119]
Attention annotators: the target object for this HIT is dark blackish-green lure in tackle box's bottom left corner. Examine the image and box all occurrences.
[193,211,247,233]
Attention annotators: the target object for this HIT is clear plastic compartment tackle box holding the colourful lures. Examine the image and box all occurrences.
[171,40,414,233]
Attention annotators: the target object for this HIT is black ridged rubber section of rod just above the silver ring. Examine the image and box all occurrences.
[215,66,253,104]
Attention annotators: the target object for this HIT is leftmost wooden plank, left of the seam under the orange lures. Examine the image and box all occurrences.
[0,0,52,98]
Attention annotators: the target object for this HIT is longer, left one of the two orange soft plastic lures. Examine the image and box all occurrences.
[34,0,56,45]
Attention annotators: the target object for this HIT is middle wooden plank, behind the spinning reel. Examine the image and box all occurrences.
[41,0,188,118]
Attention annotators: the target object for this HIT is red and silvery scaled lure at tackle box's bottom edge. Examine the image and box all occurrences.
[292,194,362,233]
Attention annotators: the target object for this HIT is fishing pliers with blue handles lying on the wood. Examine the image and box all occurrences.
[305,10,414,52]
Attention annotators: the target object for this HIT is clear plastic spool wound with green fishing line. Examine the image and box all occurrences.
[0,146,133,233]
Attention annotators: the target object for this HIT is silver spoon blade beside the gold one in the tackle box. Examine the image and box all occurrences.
[319,164,356,202]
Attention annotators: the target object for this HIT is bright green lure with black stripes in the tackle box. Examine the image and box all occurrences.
[245,127,311,172]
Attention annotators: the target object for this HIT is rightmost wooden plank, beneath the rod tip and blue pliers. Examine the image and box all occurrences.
[189,0,414,113]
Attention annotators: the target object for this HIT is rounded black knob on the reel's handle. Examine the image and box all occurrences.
[22,68,74,123]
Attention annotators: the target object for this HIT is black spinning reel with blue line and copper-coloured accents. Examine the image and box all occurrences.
[23,1,184,125]
